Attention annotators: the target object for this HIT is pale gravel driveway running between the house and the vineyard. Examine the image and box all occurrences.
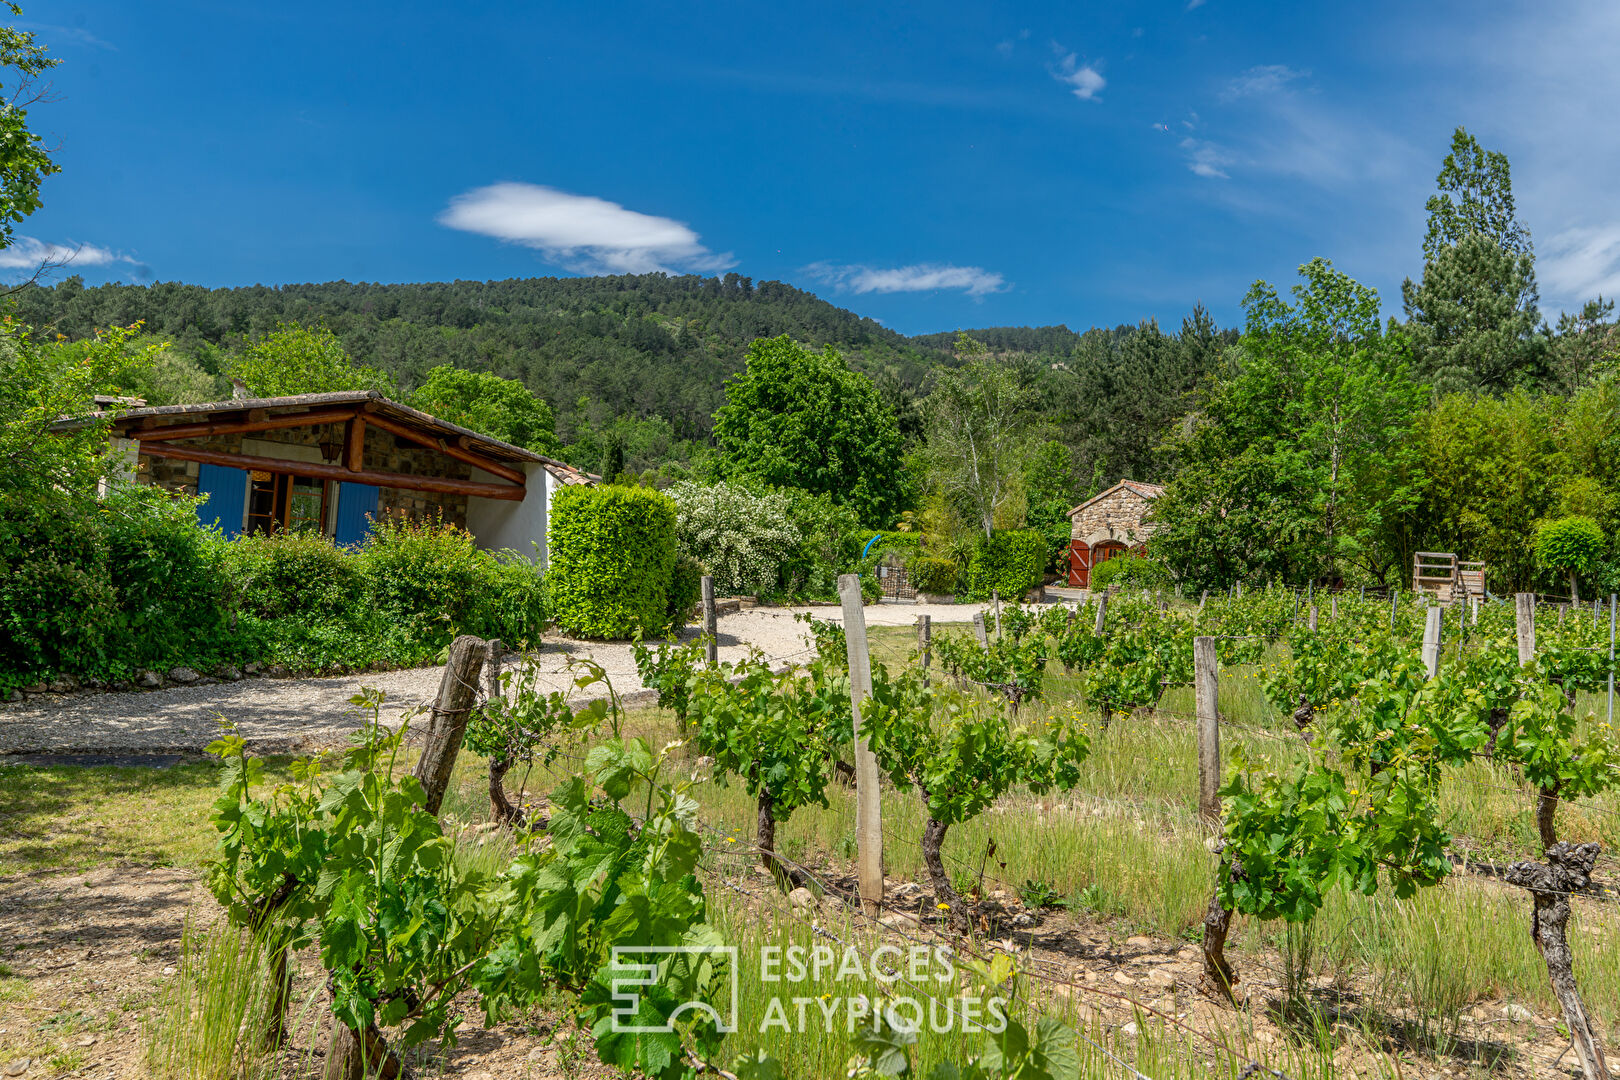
[0,604,1023,763]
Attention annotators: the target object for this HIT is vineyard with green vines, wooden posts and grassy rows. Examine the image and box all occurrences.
[164,591,1620,1080]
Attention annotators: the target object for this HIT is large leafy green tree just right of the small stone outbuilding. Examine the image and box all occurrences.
[1152,259,1426,588]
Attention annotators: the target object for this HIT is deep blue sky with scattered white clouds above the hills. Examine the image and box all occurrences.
[12,0,1620,334]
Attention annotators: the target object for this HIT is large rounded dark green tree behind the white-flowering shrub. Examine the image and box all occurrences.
[714,335,909,526]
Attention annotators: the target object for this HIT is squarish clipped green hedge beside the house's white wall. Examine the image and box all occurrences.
[548,486,676,640]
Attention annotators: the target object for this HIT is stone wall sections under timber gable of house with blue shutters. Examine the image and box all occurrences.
[136,427,473,528]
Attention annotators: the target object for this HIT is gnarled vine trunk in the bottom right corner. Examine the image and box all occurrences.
[1503,844,1612,1080]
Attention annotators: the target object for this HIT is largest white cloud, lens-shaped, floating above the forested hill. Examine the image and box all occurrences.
[439,183,737,274]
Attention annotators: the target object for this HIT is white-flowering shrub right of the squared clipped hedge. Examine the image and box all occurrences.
[664,481,804,596]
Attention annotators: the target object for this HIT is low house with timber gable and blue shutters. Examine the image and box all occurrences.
[55,390,593,565]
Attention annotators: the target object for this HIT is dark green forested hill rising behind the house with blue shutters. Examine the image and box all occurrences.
[16,274,946,439]
